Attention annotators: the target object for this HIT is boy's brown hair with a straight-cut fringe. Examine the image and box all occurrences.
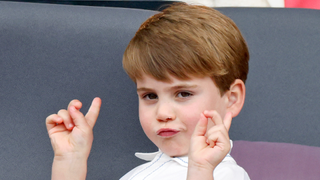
[123,3,249,95]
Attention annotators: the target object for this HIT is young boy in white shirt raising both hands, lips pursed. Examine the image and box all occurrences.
[46,3,249,180]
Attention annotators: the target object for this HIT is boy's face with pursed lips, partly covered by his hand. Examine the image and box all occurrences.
[137,75,228,157]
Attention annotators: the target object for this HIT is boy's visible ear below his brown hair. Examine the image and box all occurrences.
[226,79,246,117]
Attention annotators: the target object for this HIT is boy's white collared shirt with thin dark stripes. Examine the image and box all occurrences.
[120,143,250,180]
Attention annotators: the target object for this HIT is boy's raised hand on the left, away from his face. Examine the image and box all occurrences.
[46,98,101,161]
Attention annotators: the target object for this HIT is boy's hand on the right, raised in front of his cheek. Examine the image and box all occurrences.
[188,111,232,177]
